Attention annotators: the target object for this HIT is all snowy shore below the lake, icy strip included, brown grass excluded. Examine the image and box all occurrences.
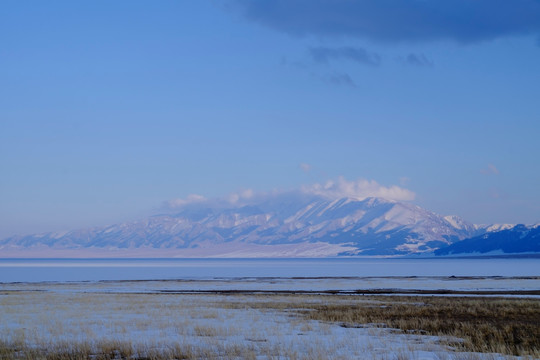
[0,277,540,360]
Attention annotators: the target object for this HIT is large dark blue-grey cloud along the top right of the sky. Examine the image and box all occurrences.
[233,0,540,43]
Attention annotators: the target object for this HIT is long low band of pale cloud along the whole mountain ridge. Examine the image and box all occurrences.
[162,177,415,211]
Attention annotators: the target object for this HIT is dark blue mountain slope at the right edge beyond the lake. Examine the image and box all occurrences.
[435,224,540,255]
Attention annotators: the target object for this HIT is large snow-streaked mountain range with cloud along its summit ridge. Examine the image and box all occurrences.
[0,194,486,257]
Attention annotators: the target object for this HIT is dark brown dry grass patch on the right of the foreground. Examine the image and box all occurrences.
[302,297,540,356]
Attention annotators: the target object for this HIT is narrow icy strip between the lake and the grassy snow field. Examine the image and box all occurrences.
[0,277,540,297]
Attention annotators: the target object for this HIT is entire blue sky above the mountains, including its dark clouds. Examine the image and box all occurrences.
[0,0,540,237]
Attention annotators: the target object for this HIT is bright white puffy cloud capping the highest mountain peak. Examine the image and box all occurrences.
[302,177,416,201]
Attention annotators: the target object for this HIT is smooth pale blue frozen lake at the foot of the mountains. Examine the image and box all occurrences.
[0,258,540,283]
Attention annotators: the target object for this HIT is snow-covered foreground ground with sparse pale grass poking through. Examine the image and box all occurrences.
[0,283,524,360]
